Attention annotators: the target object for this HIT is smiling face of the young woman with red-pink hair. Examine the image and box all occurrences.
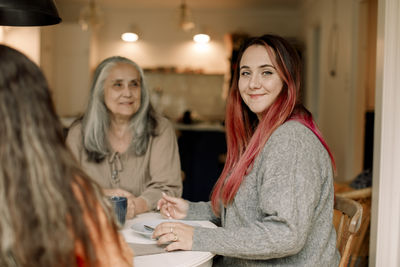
[238,45,283,119]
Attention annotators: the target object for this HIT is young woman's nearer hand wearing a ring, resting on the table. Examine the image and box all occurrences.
[152,222,194,251]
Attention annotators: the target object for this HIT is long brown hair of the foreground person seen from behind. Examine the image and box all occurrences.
[0,45,118,267]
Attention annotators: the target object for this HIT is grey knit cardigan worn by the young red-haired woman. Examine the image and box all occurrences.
[185,121,340,267]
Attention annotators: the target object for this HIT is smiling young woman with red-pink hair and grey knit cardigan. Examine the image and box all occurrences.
[153,35,340,266]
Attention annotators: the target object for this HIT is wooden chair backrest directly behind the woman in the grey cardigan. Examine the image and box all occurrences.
[334,196,363,267]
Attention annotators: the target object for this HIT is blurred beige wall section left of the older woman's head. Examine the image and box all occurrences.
[41,23,91,117]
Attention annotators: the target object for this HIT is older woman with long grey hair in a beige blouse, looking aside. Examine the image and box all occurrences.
[67,57,182,219]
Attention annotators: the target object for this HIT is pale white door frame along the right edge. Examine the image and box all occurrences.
[369,0,400,267]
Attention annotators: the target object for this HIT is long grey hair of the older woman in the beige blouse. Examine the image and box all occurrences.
[82,56,157,162]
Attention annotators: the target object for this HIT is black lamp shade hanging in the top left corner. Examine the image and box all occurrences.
[0,0,61,26]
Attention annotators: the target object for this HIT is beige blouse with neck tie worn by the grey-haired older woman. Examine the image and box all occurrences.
[67,117,182,210]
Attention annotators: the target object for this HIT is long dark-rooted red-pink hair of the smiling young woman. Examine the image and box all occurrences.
[211,35,336,216]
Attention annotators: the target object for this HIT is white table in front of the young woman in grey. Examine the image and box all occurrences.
[121,212,216,267]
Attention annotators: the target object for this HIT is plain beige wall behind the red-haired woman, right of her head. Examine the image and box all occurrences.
[303,0,364,181]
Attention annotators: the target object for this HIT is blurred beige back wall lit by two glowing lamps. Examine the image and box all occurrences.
[95,9,299,73]
